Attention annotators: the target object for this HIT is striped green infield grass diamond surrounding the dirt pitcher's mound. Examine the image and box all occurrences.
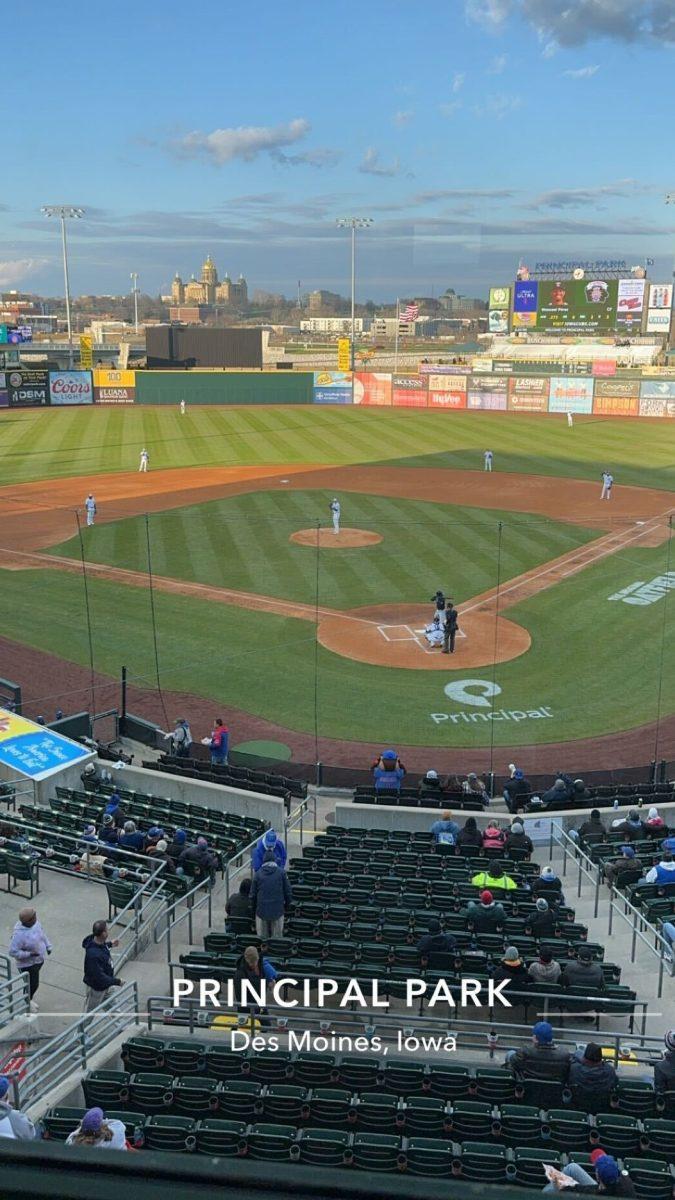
[52,491,597,608]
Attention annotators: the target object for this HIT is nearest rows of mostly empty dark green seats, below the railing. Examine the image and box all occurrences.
[35,1037,675,1200]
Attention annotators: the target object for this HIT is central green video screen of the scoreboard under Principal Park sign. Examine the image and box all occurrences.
[533,278,619,334]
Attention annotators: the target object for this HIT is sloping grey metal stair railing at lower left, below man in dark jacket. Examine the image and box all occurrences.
[8,983,138,1108]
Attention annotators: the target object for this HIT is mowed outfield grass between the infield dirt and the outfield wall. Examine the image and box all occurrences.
[0,406,675,490]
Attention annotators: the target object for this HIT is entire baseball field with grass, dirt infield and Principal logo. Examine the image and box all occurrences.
[0,407,675,769]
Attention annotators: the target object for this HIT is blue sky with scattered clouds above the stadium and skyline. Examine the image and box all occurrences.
[0,0,675,300]
